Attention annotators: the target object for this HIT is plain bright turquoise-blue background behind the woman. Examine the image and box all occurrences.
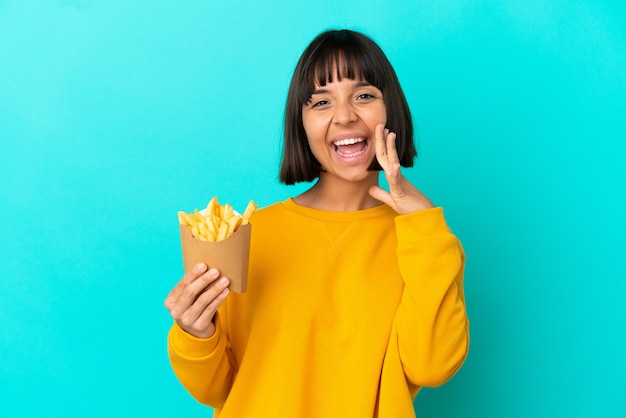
[0,0,626,418]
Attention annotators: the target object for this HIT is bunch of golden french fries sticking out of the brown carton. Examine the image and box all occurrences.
[178,196,258,241]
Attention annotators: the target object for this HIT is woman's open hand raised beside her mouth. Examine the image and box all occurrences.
[369,124,435,215]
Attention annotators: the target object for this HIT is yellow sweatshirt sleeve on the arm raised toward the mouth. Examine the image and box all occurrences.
[389,208,469,390]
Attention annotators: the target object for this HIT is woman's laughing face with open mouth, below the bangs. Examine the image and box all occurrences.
[302,77,387,181]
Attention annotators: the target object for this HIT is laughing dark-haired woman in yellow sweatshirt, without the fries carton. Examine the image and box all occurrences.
[165,30,469,418]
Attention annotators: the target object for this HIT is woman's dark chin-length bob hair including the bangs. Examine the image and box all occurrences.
[279,30,417,184]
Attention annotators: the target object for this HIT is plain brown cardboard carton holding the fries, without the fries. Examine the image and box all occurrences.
[180,224,252,293]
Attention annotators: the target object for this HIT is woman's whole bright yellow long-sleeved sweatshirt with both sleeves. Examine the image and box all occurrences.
[168,199,469,418]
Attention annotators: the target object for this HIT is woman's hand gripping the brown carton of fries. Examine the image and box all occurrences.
[165,263,229,338]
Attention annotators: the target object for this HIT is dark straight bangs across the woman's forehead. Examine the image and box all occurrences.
[298,39,385,104]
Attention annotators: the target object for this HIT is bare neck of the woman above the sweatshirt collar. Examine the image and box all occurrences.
[294,172,381,212]
